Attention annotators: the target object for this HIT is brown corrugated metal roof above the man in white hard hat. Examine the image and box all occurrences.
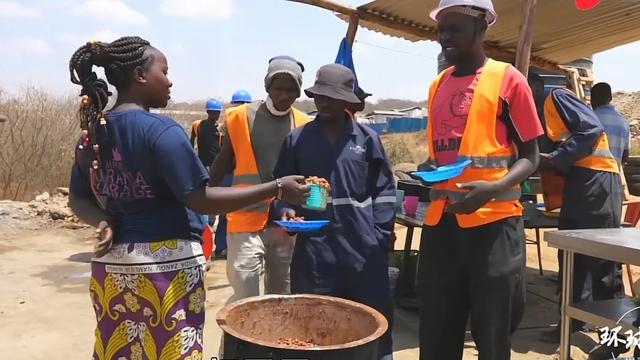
[348,0,640,64]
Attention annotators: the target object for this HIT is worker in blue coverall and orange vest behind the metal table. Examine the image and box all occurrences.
[529,74,624,352]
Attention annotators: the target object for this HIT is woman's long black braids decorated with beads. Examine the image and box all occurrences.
[69,36,153,206]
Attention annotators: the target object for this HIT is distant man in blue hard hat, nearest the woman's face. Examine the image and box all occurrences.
[191,99,223,169]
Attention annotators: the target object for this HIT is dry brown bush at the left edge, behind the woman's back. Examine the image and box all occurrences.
[0,87,80,200]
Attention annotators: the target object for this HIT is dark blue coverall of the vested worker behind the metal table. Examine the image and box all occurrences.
[540,89,624,330]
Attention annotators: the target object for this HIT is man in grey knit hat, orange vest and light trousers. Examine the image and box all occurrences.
[211,57,309,302]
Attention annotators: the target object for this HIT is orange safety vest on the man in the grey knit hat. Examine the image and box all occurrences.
[225,105,309,233]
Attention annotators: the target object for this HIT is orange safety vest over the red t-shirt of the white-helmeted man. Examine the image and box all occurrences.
[424,59,522,228]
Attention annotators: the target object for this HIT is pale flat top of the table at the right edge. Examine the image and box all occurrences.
[544,228,640,265]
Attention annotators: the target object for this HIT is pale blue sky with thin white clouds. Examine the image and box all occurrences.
[0,0,640,101]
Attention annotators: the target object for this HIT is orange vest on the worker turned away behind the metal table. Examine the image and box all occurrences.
[544,89,619,173]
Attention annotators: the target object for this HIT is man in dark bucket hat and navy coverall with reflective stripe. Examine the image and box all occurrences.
[274,64,395,360]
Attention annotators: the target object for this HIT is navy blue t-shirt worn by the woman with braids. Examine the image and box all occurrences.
[71,110,209,243]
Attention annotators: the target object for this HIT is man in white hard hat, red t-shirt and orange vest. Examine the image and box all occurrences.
[419,0,543,360]
